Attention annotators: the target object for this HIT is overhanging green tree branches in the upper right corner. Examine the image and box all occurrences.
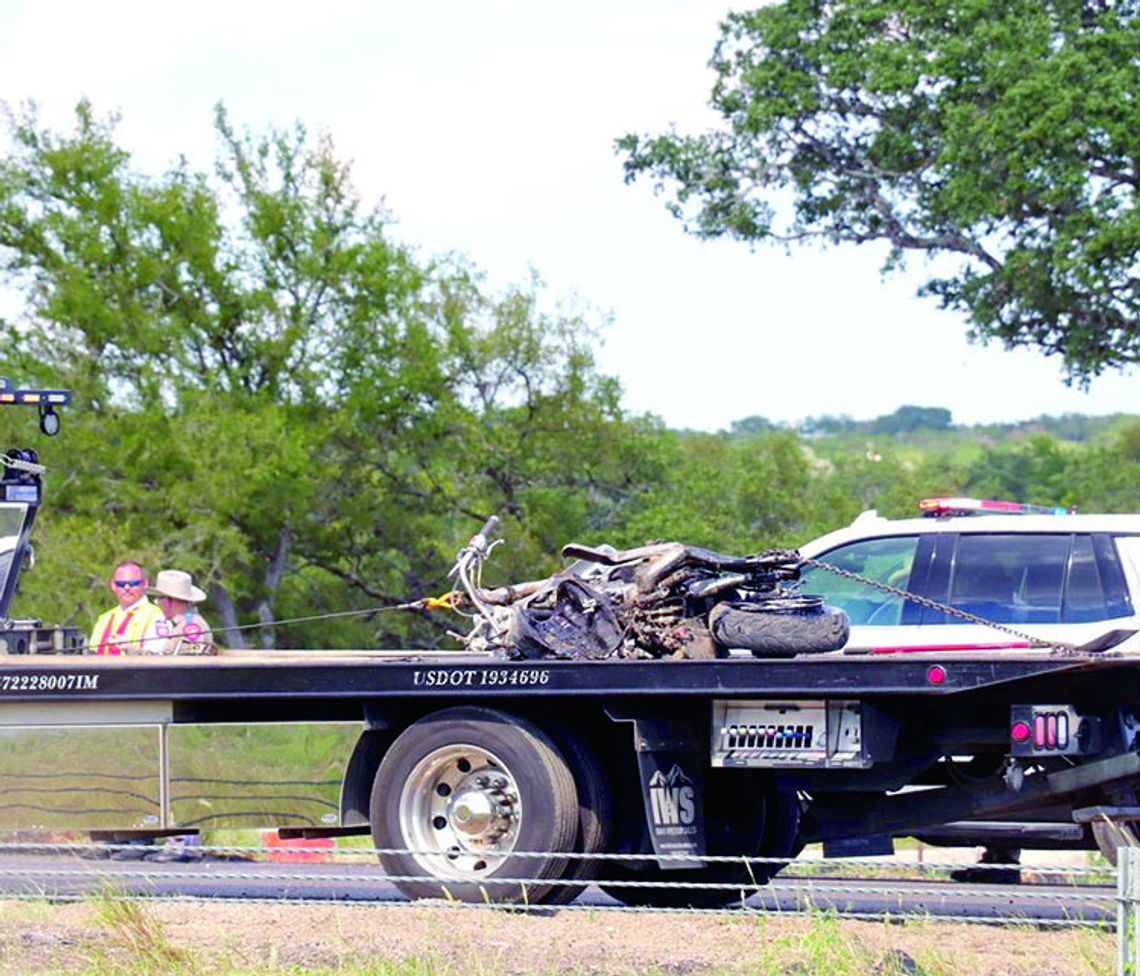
[618,0,1140,383]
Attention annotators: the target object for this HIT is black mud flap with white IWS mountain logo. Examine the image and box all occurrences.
[633,718,708,870]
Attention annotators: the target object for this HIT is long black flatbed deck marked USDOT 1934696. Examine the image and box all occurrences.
[0,651,1140,706]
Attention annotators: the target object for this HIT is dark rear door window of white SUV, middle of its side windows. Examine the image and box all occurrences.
[946,535,1073,624]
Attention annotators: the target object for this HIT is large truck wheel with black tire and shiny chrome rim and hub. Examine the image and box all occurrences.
[369,707,578,904]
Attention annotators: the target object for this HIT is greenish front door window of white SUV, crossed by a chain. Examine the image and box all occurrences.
[801,536,919,626]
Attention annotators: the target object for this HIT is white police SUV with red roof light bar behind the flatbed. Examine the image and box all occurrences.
[799,498,1140,652]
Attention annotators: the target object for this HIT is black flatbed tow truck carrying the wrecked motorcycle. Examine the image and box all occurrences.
[0,383,1140,905]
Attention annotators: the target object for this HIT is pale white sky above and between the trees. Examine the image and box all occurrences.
[0,0,1140,430]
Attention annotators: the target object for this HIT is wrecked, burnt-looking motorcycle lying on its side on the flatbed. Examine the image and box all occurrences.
[450,517,849,660]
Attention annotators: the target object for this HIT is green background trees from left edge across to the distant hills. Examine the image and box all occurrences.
[0,104,1140,648]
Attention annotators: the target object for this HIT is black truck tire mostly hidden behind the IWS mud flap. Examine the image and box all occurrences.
[601,770,801,909]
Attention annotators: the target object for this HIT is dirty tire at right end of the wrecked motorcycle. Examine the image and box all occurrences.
[709,603,850,658]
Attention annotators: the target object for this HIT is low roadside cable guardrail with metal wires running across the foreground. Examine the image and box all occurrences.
[0,841,1112,925]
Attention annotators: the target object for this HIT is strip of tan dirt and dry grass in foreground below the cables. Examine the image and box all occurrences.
[0,901,1115,976]
